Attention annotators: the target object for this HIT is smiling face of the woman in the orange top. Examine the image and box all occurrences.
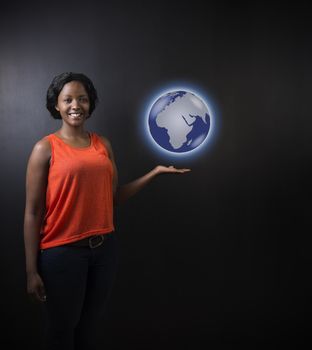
[55,81,90,126]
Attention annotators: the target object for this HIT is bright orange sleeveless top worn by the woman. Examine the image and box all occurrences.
[40,132,114,249]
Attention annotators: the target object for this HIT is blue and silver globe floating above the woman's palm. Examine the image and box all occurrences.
[148,91,210,153]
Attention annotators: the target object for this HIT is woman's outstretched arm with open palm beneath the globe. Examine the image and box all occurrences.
[102,137,191,205]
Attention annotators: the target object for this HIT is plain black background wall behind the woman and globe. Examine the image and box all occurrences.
[0,0,312,349]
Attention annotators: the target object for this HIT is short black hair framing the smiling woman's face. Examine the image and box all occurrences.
[46,72,98,119]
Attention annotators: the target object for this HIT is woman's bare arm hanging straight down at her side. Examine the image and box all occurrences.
[24,139,51,301]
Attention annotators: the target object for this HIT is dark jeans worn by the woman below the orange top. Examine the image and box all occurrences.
[38,233,117,350]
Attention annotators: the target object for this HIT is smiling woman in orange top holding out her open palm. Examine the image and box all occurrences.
[24,72,189,350]
